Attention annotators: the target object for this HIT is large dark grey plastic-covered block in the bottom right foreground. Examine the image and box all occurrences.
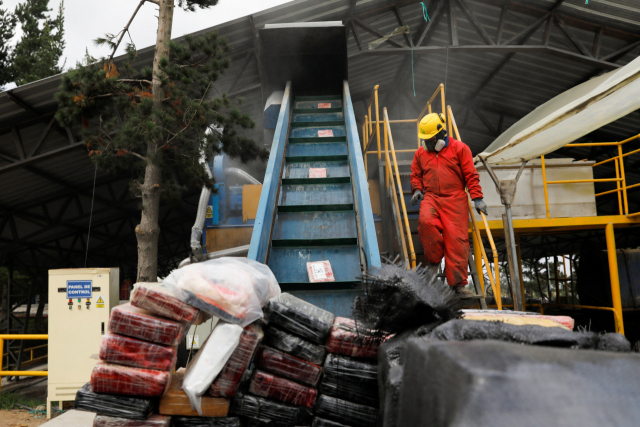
[397,338,640,427]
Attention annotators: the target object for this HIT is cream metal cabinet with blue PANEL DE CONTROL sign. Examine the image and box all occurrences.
[47,268,120,417]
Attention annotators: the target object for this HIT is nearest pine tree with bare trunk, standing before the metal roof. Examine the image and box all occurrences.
[56,0,268,282]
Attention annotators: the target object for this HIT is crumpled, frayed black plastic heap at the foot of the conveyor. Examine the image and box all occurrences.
[353,263,462,333]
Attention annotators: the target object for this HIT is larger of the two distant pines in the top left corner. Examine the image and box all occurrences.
[13,0,65,86]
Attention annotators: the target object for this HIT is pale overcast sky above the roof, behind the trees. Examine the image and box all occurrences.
[3,0,291,69]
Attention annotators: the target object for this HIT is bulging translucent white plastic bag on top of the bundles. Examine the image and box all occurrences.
[163,257,280,327]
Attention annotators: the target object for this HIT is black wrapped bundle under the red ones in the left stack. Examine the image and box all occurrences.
[74,383,157,420]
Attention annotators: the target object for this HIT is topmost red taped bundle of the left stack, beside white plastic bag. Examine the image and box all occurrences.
[131,283,199,323]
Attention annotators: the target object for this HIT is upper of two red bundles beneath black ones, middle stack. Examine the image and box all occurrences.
[256,347,322,387]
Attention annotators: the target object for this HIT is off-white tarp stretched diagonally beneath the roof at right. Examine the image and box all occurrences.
[477,57,640,165]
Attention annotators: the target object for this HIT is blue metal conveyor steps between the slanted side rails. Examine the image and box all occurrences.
[268,95,361,289]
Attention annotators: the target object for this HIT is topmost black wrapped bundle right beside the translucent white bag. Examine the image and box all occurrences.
[266,293,335,344]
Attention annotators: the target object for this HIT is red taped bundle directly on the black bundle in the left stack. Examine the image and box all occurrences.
[91,362,171,397]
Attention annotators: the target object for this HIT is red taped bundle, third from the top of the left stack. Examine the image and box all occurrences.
[100,334,178,371]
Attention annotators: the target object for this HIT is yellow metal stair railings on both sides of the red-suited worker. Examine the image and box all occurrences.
[362,84,502,310]
